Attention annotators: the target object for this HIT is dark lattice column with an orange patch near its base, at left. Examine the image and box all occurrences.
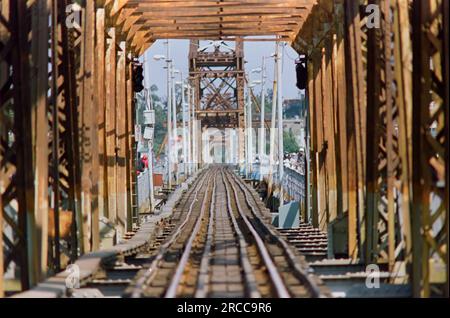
[49,0,81,271]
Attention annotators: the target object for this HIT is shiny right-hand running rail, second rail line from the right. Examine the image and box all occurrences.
[223,172,291,298]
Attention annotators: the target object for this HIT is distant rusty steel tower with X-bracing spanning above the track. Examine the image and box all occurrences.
[189,40,245,163]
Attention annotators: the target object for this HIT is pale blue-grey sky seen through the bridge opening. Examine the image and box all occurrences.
[144,40,299,99]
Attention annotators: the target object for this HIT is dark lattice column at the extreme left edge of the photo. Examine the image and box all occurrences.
[0,1,38,289]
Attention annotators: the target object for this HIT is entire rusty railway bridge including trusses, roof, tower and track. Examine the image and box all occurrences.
[0,0,449,298]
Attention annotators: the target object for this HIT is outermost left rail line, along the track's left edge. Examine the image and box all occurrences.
[131,173,208,298]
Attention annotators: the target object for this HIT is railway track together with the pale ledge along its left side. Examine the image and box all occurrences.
[16,166,330,298]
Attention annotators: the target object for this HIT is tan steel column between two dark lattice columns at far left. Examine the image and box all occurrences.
[29,1,50,282]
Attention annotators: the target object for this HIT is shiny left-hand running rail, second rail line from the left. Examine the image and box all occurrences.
[164,176,216,298]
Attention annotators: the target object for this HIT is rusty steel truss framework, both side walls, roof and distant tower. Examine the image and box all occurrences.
[0,0,449,297]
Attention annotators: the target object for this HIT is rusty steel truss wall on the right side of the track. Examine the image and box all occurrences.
[293,0,449,297]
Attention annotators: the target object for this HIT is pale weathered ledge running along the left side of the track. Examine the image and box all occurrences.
[12,171,200,298]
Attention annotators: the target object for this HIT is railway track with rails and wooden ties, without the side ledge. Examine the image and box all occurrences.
[125,167,328,298]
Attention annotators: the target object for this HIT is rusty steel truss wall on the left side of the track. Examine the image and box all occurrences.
[0,0,138,296]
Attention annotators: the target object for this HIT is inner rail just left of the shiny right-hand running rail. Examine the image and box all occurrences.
[221,171,261,298]
